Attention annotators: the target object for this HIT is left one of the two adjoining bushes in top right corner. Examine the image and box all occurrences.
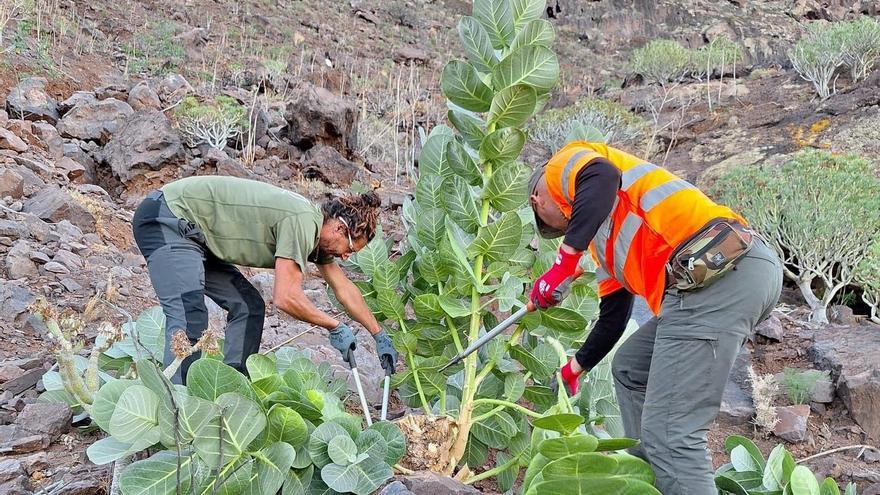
[788,23,844,100]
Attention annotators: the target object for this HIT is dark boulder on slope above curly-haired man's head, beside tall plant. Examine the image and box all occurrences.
[284,85,357,158]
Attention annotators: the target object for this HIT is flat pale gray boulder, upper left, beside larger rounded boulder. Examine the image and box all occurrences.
[58,98,134,144]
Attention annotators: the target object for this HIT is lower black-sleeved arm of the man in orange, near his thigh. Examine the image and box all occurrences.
[575,289,633,371]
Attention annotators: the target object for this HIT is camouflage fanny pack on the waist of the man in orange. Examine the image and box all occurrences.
[666,220,755,291]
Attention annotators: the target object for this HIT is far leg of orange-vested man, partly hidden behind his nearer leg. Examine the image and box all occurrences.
[611,318,657,460]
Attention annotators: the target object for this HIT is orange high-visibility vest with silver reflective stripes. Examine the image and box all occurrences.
[544,141,746,314]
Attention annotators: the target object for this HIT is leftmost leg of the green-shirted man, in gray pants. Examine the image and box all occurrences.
[132,193,208,384]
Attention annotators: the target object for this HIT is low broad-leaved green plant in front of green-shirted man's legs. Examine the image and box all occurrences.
[81,348,405,495]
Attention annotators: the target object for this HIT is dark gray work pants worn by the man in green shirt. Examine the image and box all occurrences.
[132,191,266,383]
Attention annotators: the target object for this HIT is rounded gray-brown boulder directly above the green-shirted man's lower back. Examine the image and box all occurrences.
[103,110,183,182]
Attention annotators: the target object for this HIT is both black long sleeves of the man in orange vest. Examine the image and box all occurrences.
[564,158,633,371]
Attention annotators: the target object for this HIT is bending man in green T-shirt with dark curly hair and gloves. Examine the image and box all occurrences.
[132,176,397,383]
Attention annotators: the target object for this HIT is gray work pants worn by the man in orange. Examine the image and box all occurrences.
[612,239,782,495]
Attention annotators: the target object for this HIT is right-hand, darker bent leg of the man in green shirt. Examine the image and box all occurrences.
[205,257,266,375]
